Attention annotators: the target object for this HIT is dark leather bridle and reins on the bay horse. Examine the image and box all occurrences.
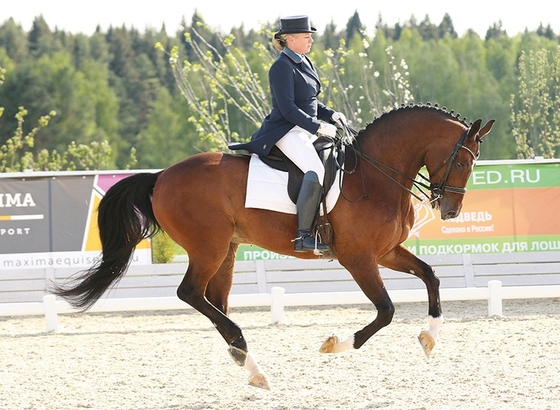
[342,121,482,207]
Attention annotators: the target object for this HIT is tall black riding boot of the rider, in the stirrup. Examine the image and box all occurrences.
[294,171,329,252]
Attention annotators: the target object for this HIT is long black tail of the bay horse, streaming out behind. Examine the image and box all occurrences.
[48,173,160,311]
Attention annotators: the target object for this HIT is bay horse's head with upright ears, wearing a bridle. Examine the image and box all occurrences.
[426,119,494,221]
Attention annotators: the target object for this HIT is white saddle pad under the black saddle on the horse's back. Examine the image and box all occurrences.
[245,154,341,215]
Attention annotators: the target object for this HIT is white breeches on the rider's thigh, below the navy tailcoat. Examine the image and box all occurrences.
[276,126,325,185]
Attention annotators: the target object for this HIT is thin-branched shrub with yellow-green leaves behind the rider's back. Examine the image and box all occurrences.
[156,23,273,151]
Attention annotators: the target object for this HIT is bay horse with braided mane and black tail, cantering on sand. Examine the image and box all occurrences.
[50,105,494,388]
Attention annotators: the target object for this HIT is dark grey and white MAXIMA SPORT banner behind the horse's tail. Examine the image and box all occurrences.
[0,173,151,270]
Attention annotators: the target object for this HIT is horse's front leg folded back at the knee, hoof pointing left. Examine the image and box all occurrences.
[319,255,395,353]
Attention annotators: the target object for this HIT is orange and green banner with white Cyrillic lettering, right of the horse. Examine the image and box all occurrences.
[405,163,560,255]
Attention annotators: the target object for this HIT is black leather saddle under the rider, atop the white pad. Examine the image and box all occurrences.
[259,136,344,204]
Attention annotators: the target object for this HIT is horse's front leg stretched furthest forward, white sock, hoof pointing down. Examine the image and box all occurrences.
[379,245,443,356]
